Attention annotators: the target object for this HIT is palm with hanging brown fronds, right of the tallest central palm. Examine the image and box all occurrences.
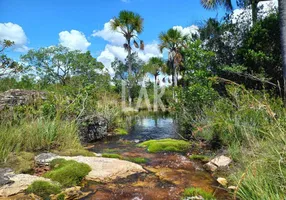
[159,28,186,87]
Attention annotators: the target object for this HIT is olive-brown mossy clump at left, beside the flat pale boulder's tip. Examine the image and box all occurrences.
[4,152,35,173]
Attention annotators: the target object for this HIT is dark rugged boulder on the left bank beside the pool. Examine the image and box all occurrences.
[78,115,108,143]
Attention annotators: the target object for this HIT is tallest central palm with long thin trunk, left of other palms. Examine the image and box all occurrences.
[111,10,144,106]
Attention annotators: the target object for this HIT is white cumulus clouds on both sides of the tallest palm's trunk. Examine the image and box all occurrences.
[92,20,163,76]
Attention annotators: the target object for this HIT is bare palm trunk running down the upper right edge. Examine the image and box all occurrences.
[278,0,286,106]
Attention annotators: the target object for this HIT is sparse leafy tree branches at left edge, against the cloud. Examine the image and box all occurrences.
[0,40,24,78]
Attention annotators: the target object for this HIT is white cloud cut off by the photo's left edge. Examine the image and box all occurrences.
[0,22,29,52]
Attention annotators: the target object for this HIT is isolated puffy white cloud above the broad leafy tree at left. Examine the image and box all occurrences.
[59,30,90,52]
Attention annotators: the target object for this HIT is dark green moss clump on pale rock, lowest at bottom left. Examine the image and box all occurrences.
[26,181,61,199]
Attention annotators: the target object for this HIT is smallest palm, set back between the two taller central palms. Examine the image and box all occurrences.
[145,57,166,84]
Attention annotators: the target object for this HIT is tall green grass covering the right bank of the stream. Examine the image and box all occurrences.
[194,85,286,200]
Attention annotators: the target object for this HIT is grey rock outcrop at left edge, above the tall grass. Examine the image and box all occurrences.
[0,89,46,110]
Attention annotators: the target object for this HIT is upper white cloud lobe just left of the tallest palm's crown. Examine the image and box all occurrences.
[92,19,125,45]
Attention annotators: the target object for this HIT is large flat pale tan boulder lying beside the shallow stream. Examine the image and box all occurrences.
[35,155,146,183]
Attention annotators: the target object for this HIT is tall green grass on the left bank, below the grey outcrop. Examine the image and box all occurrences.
[0,118,81,162]
